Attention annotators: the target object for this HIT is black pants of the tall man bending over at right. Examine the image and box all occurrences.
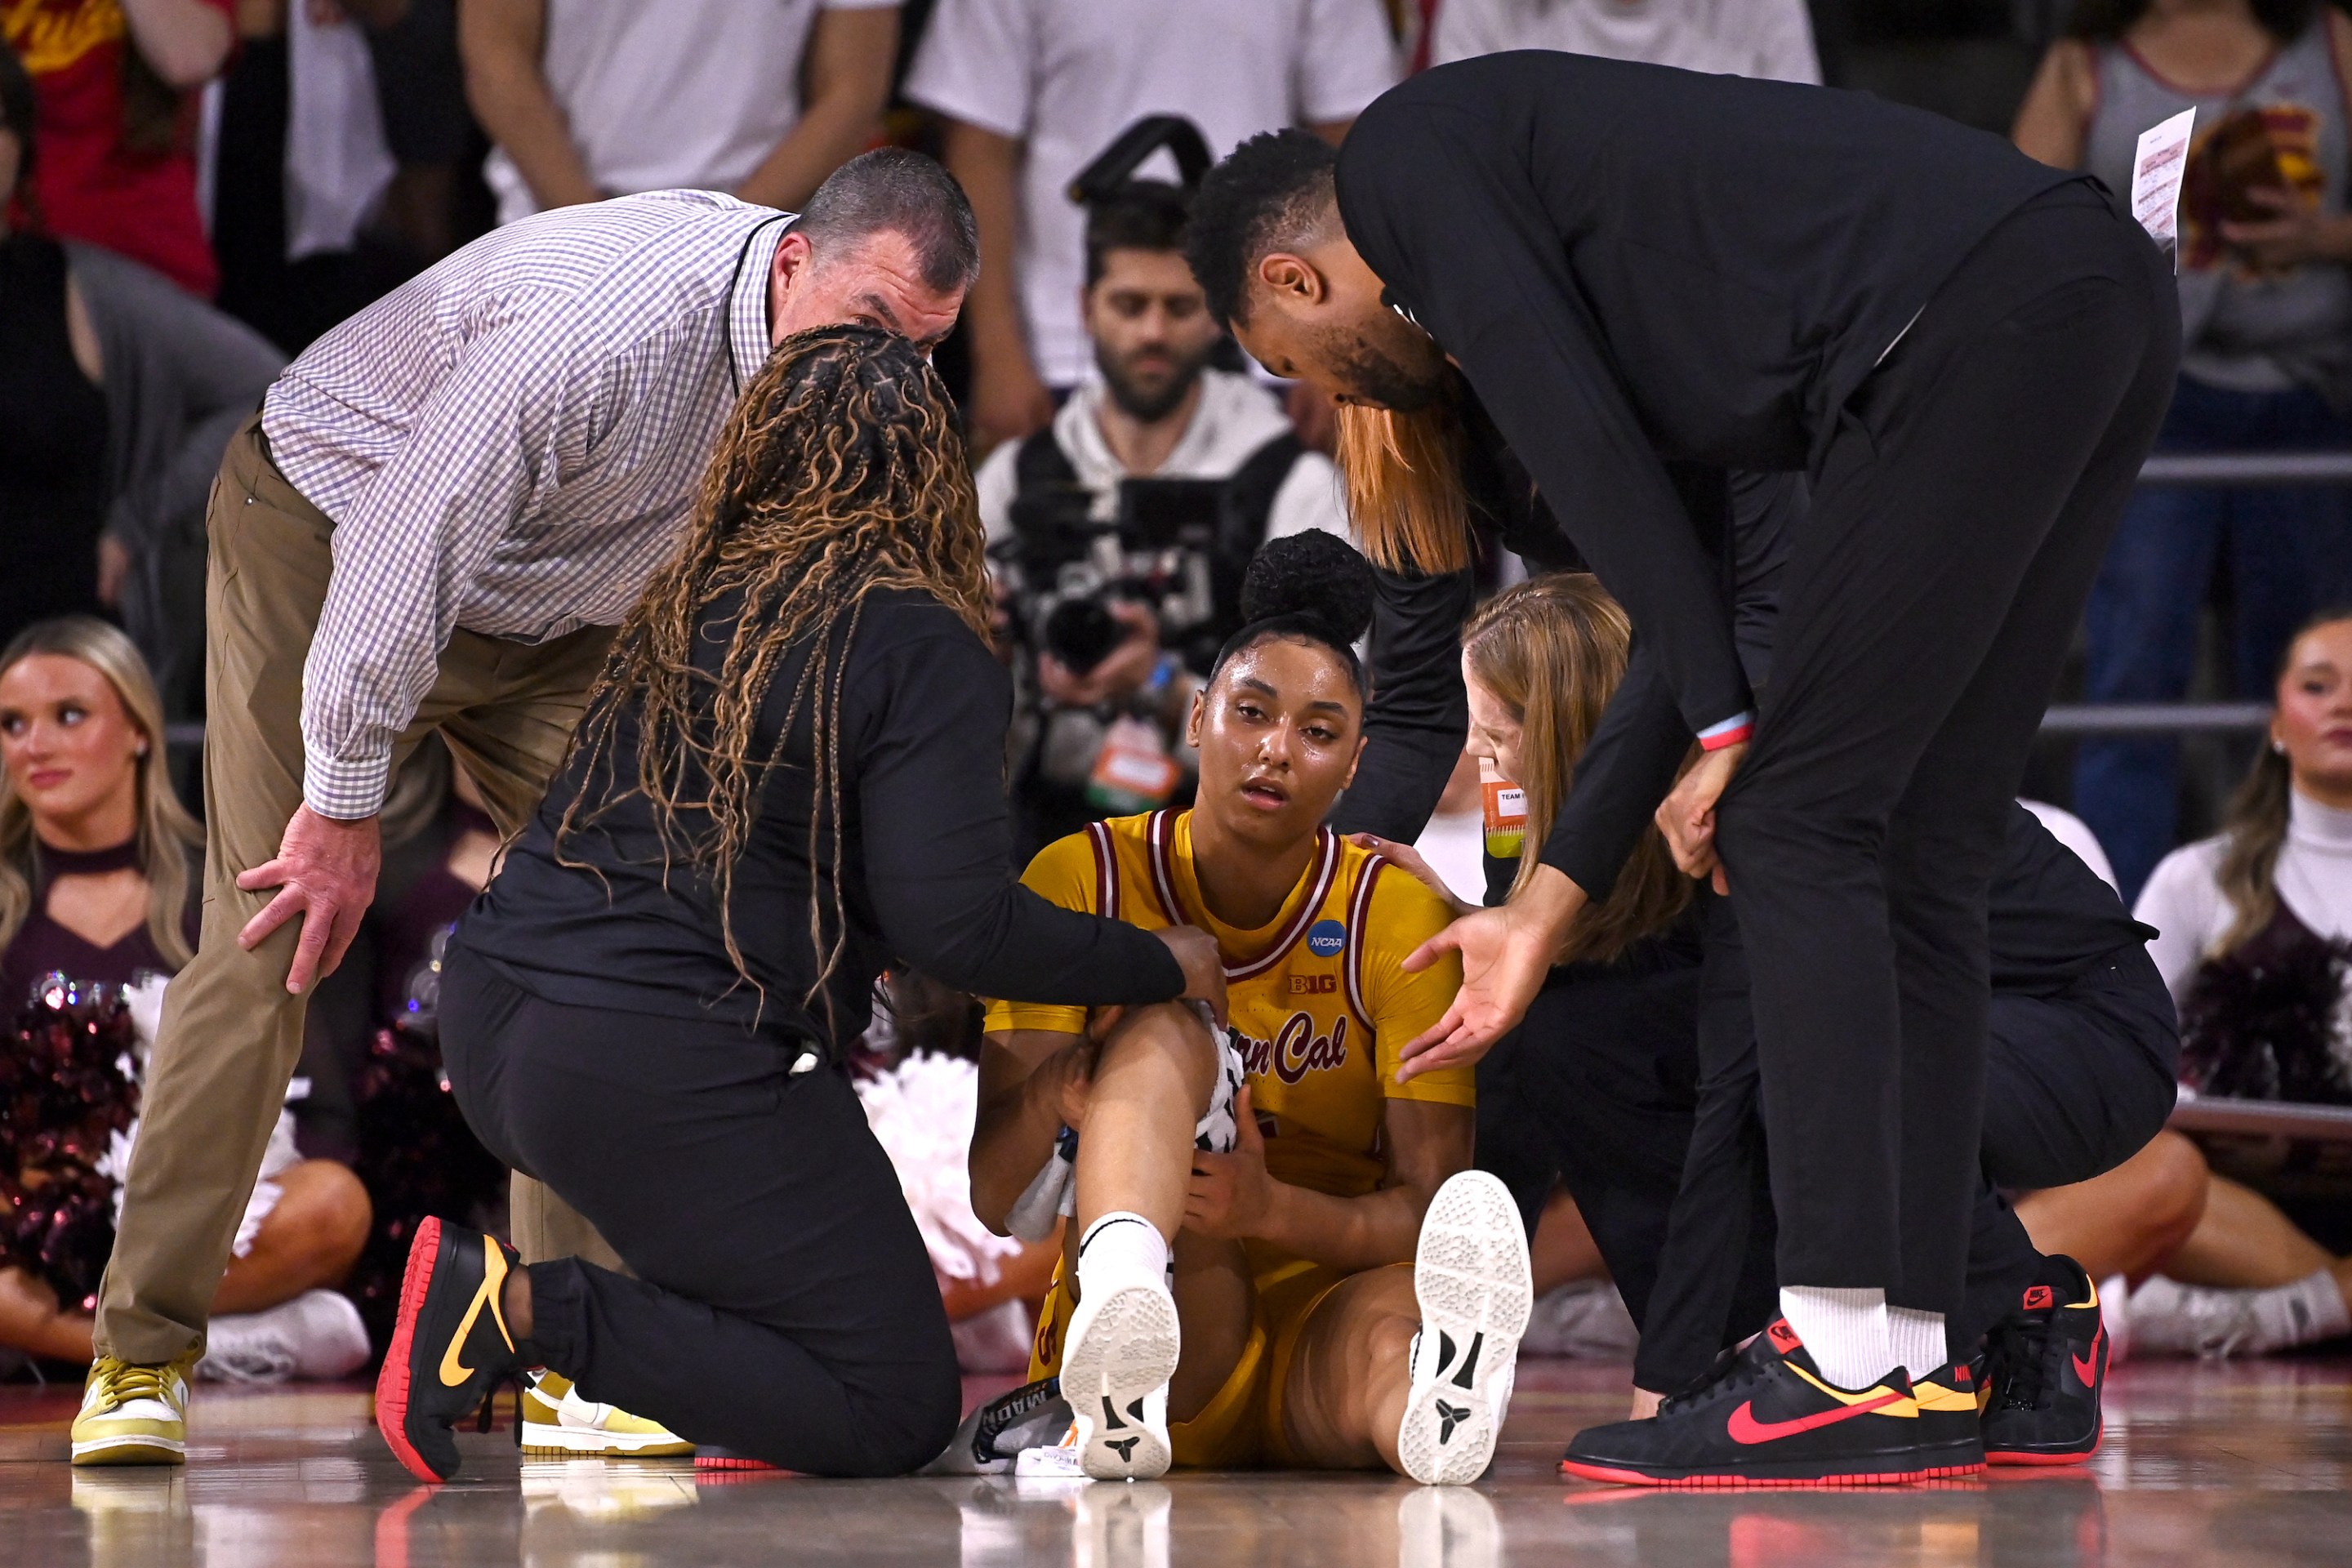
[1717,184,2180,1314]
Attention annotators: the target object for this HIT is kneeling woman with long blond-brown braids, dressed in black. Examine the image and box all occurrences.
[376,327,1223,1479]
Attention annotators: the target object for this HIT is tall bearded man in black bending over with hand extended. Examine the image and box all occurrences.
[1192,51,2180,1481]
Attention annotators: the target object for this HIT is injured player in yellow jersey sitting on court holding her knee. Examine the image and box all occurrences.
[943,533,1531,1481]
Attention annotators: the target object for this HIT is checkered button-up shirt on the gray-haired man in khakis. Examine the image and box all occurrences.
[261,190,788,818]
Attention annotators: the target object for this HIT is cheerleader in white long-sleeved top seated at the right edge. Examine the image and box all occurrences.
[2018,611,2352,1356]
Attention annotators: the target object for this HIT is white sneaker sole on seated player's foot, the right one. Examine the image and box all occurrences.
[1397,1171,1536,1486]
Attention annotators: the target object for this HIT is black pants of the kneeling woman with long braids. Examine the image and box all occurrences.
[440,945,962,1477]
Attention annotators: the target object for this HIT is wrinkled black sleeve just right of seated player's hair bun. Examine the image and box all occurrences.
[1331,567,1477,844]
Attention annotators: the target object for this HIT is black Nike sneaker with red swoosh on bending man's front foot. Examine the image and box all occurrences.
[1559,1319,1973,1488]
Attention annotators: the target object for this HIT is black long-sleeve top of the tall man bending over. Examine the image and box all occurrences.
[1339,49,2079,747]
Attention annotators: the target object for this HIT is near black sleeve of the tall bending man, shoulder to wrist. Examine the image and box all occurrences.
[1339,104,1750,733]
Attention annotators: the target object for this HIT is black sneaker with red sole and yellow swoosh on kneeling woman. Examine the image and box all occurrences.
[376,1218,522,1481]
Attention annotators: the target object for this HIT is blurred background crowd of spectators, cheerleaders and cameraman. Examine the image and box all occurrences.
[0,0,2352,1375]
